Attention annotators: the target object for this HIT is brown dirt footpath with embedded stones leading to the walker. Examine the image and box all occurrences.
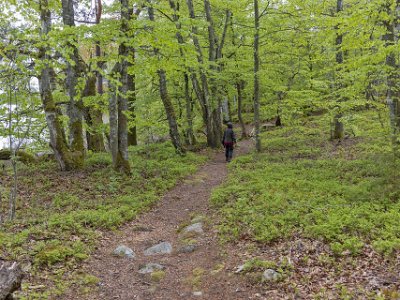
[68,140,254,300]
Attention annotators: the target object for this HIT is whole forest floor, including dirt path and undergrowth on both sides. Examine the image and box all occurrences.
[0,111,400,300]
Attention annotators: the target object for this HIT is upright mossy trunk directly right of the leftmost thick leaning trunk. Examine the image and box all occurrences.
[62,0,85,165]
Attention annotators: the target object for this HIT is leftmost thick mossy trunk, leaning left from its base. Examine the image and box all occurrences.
[39,0,82,171]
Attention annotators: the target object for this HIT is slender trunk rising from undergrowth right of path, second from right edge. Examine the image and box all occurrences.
[332,0,344,140]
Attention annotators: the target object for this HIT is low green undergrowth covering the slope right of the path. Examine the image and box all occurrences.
[212,112,400,255]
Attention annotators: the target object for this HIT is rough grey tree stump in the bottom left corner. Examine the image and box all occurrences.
[0,260,23,300]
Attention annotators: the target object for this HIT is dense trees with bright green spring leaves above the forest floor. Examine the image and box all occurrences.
[0,0,400,169]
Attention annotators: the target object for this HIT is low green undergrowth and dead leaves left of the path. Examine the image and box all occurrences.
[0,143,206,299]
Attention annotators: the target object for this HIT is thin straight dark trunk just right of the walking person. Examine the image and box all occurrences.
[253,0,261,152]
